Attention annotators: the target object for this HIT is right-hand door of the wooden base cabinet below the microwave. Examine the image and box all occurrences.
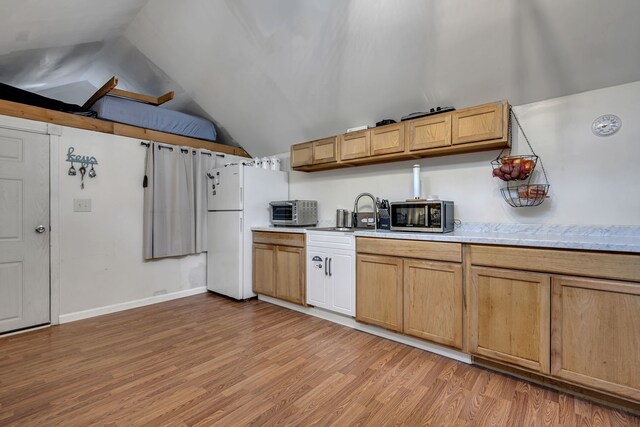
[404,260,462,349]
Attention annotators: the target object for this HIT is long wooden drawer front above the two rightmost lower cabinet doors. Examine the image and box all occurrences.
[469,245,640,282]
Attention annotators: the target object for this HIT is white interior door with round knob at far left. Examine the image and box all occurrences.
[0,128,50,333]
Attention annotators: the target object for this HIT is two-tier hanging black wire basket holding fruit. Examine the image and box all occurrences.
[491,109,550,208]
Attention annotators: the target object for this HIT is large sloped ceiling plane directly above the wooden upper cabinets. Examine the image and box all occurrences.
[124,0,640,157]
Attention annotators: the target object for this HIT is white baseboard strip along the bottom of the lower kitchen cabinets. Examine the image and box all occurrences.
[258,295,472,364]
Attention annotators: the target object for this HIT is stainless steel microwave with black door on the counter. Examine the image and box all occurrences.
[390,200,453,233]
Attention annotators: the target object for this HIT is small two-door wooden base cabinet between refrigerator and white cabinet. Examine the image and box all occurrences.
[252,231,306,305]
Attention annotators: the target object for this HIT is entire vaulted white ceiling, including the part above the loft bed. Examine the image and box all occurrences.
[0,0,640,156]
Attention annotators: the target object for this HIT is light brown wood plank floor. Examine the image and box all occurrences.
[0,294,640,426]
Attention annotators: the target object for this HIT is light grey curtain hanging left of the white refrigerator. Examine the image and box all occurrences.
[144,143,215,259]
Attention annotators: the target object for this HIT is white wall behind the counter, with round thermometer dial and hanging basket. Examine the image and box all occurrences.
[289,82,640,225]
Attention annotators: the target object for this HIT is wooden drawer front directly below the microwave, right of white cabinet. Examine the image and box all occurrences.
[356,237,462,262]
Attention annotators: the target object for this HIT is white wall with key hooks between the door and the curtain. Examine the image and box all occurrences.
[58,127,206,315]
